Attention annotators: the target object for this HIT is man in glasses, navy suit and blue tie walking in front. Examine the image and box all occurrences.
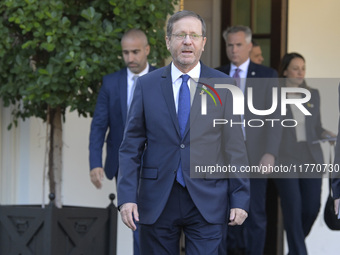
[118,11,249,255]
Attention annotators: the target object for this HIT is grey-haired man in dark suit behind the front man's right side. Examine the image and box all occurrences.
[217,26,282,255]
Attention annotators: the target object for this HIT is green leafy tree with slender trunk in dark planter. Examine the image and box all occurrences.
[0,0,177,206]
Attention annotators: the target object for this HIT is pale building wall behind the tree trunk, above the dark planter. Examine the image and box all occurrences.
[0,108,133,255]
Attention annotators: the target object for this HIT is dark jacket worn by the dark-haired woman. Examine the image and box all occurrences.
[279,89,324,164]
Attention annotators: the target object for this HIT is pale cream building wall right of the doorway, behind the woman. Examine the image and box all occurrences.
[286,0,340,255]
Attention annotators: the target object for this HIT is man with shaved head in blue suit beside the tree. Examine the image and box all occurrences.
[89,29,155,254]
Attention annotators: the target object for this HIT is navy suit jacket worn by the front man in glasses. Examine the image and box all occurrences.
[118,64,249,224]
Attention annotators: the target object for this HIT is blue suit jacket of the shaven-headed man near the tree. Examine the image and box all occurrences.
[89,65,156,180]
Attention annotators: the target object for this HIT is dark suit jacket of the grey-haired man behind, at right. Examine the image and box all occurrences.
[217,61,282,165]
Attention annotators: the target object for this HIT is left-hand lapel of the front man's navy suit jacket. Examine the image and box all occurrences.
[161,64,181,136]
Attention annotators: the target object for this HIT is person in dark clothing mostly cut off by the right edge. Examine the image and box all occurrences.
[332,84,340,214]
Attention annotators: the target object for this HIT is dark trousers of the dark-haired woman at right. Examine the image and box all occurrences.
[274,142,322,255]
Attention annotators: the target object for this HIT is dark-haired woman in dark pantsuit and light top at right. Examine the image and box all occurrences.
[275,53,335,255]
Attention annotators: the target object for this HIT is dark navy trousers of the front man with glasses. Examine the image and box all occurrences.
[139,181,224,255]
